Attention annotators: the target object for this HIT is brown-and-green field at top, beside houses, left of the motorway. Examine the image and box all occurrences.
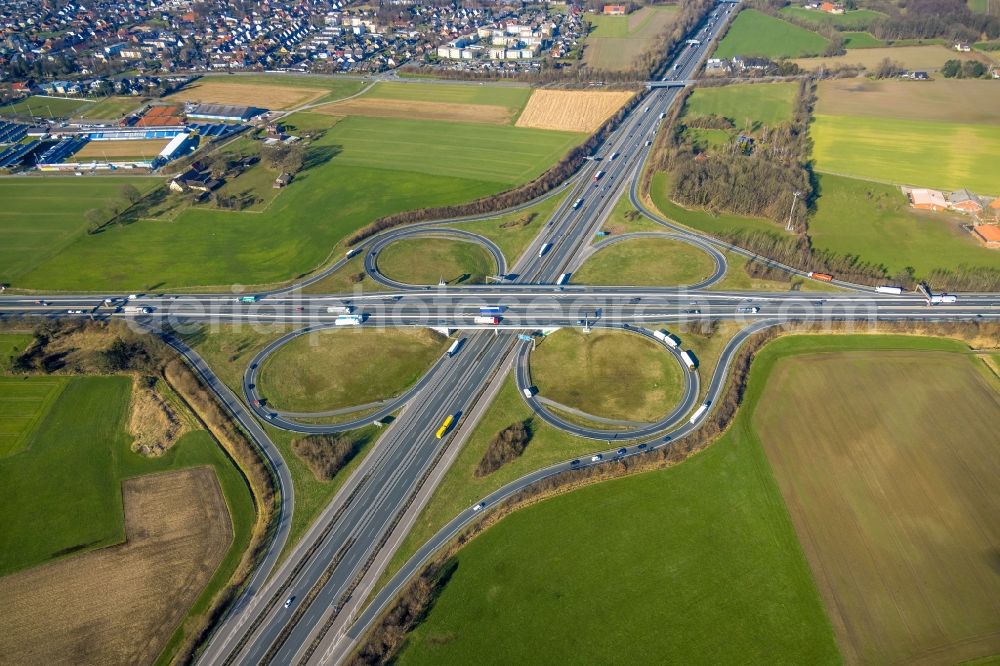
[583,6,677,71]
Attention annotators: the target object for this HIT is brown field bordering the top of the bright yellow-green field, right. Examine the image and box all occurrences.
[816,79,1000,125]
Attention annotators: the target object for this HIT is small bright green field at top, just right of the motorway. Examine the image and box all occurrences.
[715,9,827,58]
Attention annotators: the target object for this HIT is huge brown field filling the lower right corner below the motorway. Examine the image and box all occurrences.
[753,348,1000,664]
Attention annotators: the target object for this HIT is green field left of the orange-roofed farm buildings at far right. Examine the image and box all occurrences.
[809,175,998,276]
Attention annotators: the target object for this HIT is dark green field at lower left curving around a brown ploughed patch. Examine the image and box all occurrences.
[0,370,254,589]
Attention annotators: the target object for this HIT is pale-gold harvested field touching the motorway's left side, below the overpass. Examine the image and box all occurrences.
[516,90,634,132]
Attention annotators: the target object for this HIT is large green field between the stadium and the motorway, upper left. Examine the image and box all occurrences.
[7,114,583,290]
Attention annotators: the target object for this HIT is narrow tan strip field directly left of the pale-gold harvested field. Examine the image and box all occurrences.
[313,97,514,125]
